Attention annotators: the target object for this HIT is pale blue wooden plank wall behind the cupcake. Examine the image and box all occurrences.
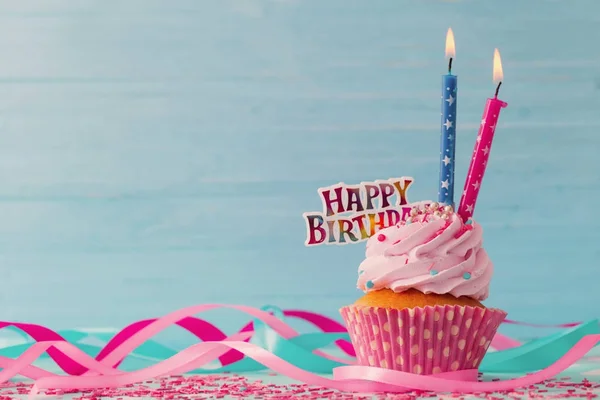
[0,0,600,338]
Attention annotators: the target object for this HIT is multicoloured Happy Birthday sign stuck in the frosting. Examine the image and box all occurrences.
[302,177,414,246]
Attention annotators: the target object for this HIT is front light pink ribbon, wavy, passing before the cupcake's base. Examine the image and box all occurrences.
[14,334,600,394]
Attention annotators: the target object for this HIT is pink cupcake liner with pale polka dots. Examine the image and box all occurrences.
[340,305,506,375]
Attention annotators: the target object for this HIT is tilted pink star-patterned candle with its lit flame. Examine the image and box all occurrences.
[458,49,508,221]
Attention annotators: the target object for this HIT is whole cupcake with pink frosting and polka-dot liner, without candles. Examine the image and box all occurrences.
[340,203,506,375]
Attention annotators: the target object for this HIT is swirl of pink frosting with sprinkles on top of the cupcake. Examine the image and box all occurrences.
[357,208,494,300]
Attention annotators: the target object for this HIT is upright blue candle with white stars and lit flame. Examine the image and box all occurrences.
[438,29,458,207]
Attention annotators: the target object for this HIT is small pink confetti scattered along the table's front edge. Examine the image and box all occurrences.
[0,374,600,400]
